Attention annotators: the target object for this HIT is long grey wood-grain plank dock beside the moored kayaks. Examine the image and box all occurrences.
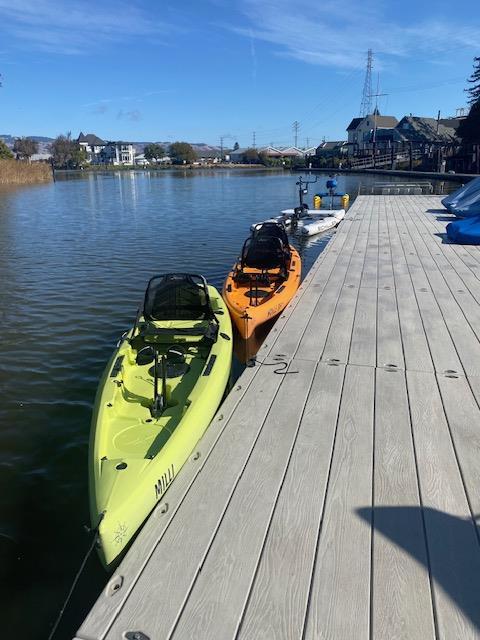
[77,196,480,640]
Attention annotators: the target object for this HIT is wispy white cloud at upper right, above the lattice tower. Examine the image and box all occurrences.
[230,0,480,69]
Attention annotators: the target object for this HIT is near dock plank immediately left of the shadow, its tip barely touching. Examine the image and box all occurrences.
[304,365,374,640]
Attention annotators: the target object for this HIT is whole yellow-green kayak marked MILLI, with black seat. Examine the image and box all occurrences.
[89,274,232,566]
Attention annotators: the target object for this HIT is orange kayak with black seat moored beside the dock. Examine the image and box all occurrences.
[222,222,302,339]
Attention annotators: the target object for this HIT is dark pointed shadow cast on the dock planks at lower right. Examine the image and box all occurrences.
[357,506,480,629]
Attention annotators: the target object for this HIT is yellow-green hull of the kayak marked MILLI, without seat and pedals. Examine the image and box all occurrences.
[89,286,232,567]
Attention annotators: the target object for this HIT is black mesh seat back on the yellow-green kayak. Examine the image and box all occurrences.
[143,273,213,321]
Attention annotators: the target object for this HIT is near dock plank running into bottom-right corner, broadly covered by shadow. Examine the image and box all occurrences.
[407,371,480,640]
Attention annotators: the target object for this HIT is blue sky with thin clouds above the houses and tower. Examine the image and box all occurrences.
[0,0,480,146]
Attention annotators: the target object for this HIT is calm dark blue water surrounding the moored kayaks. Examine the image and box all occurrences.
[0,171,456,640]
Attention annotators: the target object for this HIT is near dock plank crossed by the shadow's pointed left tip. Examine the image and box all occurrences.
[374,369,435,640]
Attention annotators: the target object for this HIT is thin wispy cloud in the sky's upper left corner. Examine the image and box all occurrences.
[0,0,176,55]
